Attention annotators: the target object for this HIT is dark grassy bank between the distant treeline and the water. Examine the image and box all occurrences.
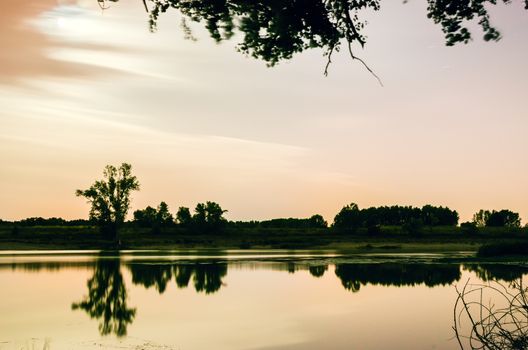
[0,226,528,253]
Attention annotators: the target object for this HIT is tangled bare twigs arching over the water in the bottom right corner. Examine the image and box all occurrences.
[453,278,528,350]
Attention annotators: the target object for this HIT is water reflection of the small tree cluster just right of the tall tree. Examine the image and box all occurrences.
[129,262,227,294]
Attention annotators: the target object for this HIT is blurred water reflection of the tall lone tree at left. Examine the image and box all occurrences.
[72,258,136,337]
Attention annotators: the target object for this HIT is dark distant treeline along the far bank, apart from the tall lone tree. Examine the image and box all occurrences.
[0,201,521,233]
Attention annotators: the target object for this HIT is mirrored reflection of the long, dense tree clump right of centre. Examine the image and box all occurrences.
[335,263,460,293]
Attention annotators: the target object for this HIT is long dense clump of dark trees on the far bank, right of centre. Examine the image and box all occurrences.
[332,203,458,232]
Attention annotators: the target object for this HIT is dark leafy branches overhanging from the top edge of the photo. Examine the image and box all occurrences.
[97,0,528,74]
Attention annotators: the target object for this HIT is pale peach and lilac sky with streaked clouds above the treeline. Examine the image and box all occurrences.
[0,0,528,223]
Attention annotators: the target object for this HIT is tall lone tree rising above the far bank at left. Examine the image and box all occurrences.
[75,163,139,240]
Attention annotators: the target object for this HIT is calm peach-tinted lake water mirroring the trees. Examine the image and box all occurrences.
[0,251,528,349]
